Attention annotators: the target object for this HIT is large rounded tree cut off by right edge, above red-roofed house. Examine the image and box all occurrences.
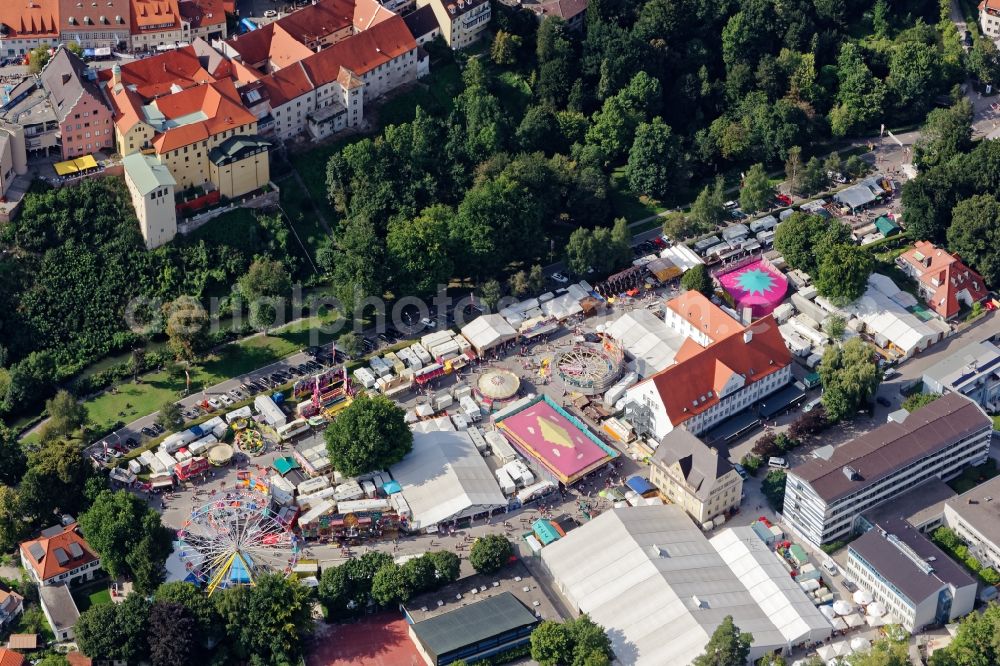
[948,194,1000,285]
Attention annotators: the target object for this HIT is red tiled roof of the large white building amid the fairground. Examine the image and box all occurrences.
[645,315,791,426]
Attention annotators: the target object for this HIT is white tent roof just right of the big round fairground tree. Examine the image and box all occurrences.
[390,417,507,529]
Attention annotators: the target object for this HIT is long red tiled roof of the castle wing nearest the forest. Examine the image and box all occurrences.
[302,16,417,86]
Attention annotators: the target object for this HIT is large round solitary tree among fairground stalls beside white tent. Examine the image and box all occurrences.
[326,394,413,476]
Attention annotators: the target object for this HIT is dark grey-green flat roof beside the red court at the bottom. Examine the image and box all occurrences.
[412,592,538,656]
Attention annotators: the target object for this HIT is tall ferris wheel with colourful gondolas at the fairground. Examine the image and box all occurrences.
[177,489,299,595]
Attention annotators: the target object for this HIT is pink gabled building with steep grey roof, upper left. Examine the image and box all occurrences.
[40,48,115,160]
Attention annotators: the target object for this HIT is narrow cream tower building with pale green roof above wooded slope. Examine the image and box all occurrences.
[122,150,177,250]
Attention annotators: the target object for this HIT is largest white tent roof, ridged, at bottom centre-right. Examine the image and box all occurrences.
[541,505,820,666]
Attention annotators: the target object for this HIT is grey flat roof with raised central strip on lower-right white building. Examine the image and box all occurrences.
[848,518,976,604]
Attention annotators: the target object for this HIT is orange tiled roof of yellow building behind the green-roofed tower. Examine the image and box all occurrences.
[153,79,257,154]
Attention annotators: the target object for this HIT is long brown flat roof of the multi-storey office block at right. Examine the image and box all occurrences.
[790,393,993,502]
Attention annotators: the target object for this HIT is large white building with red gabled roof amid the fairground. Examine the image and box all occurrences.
[625,308,792,440]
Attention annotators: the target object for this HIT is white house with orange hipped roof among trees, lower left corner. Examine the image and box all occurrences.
[20,522,101,587]
